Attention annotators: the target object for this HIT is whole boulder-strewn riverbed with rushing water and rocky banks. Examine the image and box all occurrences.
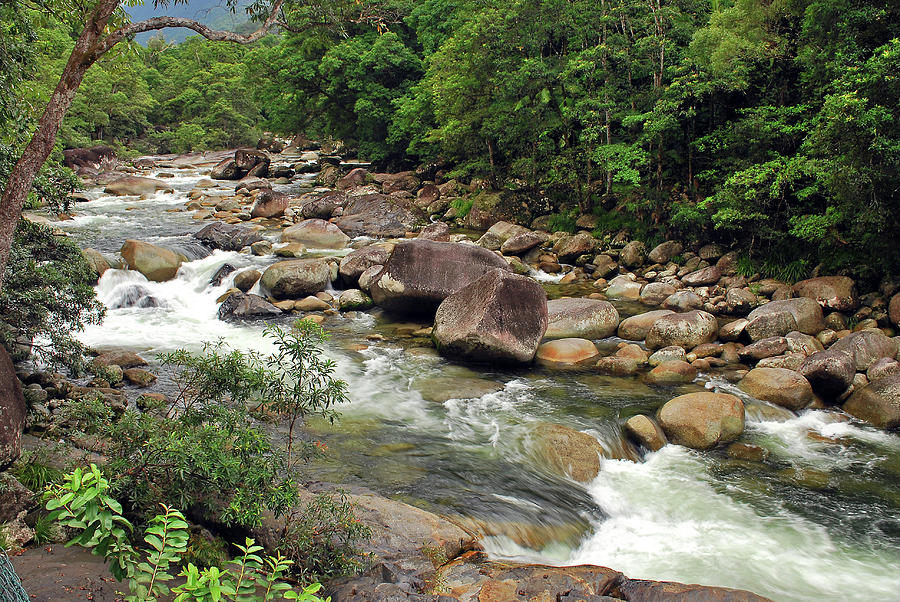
[3,146,900,600]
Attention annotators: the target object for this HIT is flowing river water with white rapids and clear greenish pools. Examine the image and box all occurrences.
[51,165,900,600]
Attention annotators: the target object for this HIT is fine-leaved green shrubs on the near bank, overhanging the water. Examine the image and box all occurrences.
[53,321,370,582]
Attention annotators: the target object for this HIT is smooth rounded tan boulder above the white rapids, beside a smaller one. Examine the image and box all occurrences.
[657,391,744,449]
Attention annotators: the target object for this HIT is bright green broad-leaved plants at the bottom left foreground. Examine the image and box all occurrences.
[47,464,321,602]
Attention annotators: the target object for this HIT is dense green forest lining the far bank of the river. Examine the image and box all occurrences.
[12,0,900,276]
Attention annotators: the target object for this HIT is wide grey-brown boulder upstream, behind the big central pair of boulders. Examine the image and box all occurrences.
[334,194,420,238]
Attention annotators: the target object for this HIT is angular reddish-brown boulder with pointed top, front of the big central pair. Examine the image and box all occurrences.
[433,268,547,363]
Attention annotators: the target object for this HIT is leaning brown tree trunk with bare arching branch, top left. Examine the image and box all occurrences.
[0,0,284,290]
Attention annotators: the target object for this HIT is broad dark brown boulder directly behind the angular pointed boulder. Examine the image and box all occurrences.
[370,239,509,313]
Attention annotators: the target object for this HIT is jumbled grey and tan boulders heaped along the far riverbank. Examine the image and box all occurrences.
[86,144,900,449]
